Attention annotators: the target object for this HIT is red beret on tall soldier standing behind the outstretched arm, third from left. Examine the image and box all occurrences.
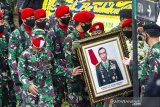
[55,5,69,18]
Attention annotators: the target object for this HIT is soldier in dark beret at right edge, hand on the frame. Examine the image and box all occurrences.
[123,24,160,96]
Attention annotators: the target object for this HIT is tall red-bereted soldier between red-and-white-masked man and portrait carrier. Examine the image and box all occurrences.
[47,5,73,107]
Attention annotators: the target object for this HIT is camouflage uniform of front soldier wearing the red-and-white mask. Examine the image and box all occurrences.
[18,47,71,107]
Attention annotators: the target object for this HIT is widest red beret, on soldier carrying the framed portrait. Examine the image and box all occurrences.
[73,11,94,22]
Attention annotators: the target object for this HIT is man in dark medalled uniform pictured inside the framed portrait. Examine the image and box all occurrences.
[96,47,123,87]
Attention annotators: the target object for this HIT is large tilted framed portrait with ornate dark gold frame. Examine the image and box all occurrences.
[75,30,132,103]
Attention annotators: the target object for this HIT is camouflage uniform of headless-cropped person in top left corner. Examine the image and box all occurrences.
[0,0,15,31]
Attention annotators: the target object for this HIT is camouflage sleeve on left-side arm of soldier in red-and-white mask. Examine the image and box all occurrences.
[18,53,32,90]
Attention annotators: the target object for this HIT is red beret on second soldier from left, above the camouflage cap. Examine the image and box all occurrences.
[34,9,46,20]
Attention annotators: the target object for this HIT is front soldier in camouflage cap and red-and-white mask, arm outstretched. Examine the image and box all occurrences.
[18,29,83,107]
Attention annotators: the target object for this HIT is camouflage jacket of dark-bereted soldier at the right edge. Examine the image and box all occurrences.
[139,42,160,84]
